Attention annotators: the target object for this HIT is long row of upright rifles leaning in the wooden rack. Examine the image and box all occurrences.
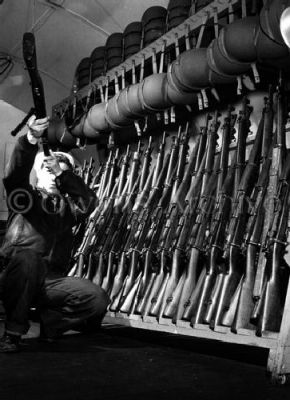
[69,82,290,335]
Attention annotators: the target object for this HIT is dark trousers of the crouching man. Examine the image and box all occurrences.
[0,250,109,336]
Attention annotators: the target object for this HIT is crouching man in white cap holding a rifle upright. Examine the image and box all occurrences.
[0,116,109,352]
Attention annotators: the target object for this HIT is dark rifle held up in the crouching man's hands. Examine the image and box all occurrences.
[22,32,50,156]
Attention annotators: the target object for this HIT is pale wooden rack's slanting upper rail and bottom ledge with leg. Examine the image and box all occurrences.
[52,0,290,384]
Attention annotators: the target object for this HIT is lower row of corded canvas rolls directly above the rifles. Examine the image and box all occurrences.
[48,0,290,148]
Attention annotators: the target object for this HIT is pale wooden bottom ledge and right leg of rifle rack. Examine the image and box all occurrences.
[104,268,290,385]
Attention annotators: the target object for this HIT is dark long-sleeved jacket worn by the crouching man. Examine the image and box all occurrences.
[1,136,96,274]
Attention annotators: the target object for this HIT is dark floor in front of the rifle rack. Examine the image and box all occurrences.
[0,323,290,400]
